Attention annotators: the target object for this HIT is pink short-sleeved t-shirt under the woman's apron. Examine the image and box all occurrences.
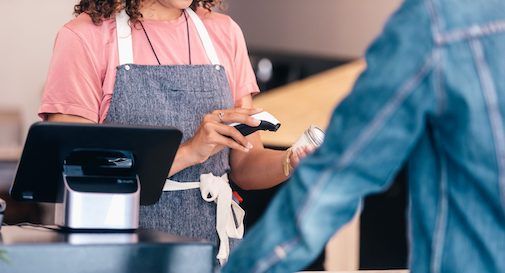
[39,9,259,122]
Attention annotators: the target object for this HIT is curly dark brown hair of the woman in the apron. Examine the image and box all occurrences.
[74,0,221,25]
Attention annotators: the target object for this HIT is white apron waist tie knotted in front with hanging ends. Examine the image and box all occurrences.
[163,173,245,265]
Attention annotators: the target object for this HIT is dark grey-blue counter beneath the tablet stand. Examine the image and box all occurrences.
[0,226,215,273]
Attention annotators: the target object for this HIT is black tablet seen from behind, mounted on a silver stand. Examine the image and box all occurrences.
[10,122,182,205]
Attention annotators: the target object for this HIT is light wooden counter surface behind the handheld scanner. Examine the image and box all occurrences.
[254,60,366,147]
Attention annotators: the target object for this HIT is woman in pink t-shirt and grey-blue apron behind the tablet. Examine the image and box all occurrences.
[39,0,312,262]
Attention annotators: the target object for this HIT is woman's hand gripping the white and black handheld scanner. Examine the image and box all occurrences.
[183,108,262,163]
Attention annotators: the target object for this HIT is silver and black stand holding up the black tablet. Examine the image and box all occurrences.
[55,149,140,229]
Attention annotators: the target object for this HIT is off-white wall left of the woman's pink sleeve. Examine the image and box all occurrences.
[0,0,75,134]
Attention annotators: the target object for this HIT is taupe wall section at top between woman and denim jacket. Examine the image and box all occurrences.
[227,0,402,57]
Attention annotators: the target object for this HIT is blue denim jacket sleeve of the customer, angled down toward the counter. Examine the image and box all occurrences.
[223,1,437,273]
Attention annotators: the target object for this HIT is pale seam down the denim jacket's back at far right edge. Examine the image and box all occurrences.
[470,39,505,216]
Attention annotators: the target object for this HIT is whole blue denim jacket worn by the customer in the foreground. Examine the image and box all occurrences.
[223,0,505,273]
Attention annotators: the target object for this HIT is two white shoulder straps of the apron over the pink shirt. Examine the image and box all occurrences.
[116,8,221,65]
